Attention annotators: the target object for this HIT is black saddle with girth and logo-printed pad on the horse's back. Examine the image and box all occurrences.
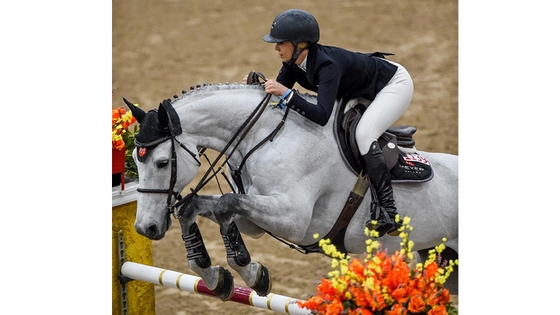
[300,99,434,253]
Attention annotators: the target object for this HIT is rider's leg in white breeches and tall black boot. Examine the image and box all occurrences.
[356,63,414,236]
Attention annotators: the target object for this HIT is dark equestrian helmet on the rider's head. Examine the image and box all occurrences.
[263,9,319,46]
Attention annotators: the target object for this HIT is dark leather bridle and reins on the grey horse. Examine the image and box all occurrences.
[135,73,289,219]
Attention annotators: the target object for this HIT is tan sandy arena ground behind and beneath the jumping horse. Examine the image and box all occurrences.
[112,0,458,315]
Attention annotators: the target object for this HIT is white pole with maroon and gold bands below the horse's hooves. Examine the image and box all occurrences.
[121,261,311,315]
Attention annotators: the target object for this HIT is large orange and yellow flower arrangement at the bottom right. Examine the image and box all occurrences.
[298,217,458,315]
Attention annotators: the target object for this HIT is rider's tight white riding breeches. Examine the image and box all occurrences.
[356,61,414,155]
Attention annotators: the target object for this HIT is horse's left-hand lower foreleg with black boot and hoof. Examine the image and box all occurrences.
[179,217,234,301]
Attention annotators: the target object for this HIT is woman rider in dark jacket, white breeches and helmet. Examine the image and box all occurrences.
[243,9,414,236]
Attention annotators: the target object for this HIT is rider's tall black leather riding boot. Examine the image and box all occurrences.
[363,141,401,237]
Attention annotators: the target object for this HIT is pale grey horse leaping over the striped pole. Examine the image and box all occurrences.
[127,84,458,300]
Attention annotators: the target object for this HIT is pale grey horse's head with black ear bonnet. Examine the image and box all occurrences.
[125,99,200,240]
